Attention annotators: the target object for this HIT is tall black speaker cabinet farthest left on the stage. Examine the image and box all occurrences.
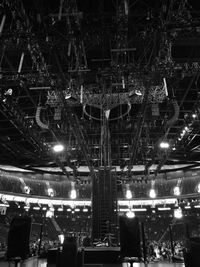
[7,217,31,260]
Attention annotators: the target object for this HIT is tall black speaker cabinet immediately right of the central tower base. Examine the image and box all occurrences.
[119,216,141,258]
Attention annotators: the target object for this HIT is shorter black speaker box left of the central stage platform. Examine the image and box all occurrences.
[60,237,78,267]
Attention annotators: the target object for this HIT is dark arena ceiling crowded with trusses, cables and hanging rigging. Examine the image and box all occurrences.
[0,0,200,179]
